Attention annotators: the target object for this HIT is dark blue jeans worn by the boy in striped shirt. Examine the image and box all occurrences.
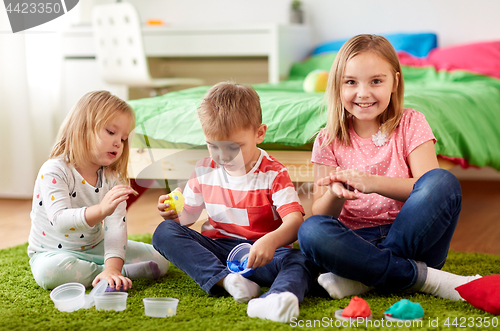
[153,220,318,302]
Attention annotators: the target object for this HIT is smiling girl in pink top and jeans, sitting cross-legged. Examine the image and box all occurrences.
[298,35,480,300]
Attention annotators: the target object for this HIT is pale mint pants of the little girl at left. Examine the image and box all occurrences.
[30,240,169,290]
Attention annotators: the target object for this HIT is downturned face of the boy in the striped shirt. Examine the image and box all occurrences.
[205,124,267,176]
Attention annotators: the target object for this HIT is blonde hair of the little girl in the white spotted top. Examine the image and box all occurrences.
[50,91,135,183]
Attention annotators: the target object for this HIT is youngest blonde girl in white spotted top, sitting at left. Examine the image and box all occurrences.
[28,91,169,290]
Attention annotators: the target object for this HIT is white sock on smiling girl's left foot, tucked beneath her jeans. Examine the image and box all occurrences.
[318,272,371,299]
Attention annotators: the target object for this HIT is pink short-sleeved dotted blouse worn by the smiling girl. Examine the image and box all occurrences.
[311,108,436,230]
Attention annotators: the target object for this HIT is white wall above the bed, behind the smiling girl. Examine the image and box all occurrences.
[305,0,500,46]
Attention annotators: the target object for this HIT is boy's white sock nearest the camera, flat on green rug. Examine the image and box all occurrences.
[247,292,299,323]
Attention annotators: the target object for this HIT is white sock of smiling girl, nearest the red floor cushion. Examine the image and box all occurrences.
[419,267,481,301]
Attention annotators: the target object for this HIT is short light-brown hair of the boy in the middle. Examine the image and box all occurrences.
[198,82,262,140]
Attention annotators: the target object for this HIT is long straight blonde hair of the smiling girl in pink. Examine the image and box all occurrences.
[324,34,404,146]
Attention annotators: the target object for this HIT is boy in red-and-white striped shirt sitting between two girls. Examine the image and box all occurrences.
[153,83,315,323]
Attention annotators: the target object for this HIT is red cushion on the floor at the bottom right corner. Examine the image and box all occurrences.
[455,275,500,315]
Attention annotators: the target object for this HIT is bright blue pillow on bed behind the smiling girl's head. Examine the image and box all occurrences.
[312,33,437,57]
